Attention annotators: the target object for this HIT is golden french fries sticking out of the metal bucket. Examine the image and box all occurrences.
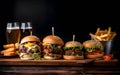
[89,27,117,41]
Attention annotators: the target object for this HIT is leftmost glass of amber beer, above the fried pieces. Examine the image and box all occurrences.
[6,22,21,44]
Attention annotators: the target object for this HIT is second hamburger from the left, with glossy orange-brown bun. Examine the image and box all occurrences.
[42,35,64,60]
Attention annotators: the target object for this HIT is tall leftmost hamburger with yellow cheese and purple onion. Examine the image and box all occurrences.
[19,35,42,60]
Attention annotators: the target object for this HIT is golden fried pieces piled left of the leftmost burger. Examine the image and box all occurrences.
[0,43,19,56]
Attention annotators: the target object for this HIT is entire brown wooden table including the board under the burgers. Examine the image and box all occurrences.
[0,58,120,75]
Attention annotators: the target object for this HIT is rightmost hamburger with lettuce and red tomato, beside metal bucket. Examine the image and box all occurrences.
[83,40,104,59]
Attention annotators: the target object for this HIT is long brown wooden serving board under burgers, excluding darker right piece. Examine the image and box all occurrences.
[0,58,94,66]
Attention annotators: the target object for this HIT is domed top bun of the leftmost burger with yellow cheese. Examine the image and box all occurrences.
[20,35,40,44]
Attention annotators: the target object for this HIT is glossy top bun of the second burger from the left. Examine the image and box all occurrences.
[43,35,64,46]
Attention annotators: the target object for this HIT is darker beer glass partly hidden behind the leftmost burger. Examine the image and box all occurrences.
[21,22,32,39]
